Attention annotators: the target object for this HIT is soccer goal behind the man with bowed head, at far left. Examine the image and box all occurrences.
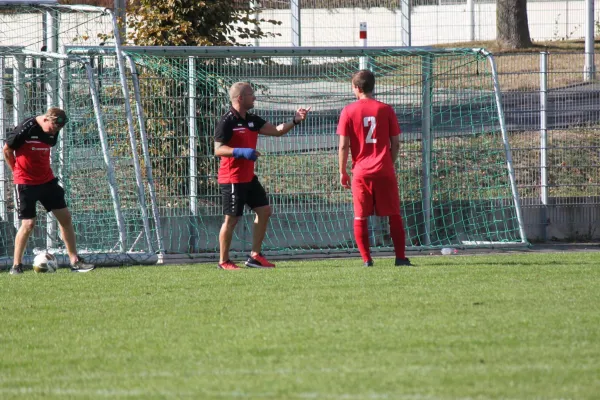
[0,1,158,266]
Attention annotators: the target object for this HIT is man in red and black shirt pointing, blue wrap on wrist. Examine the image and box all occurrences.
[215,82,310,270]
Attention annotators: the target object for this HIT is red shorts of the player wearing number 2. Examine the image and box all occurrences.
[352,176,400,217]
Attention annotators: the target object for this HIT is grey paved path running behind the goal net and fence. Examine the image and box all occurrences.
[257,82,600,152]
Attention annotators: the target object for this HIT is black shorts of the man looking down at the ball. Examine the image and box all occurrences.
[16,178,67,219]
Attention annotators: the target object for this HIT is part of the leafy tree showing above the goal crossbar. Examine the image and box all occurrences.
[127,0,281,46]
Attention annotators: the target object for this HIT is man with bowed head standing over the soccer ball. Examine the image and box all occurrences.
[3,107,94,275]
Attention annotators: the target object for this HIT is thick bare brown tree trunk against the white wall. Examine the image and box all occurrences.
[496,0,532,49]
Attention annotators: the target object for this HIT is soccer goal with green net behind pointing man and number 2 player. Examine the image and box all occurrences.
[64,46,527,259]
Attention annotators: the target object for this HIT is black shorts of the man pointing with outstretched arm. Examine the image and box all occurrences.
[219,176,269,217]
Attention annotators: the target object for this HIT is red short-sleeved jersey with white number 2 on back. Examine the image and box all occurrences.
[337,99,400,177]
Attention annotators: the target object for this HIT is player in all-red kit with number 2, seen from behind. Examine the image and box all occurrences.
[337,70,412,267]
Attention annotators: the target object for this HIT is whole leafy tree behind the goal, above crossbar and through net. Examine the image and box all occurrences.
[123,0,281,206]
